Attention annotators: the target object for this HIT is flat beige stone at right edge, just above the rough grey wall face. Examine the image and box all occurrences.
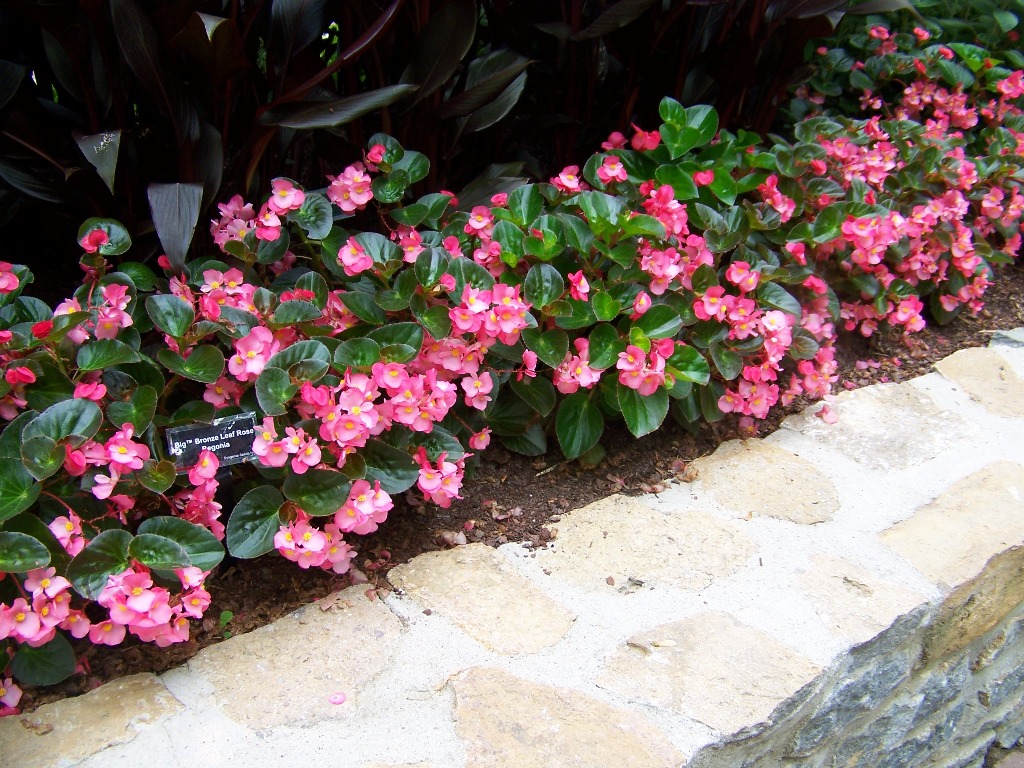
[881,462,1024,587]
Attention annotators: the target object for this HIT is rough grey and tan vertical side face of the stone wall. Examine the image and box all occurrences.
[688,547,1024,768]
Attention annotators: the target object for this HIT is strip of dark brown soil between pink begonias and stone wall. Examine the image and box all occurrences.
[22,265,1024,711]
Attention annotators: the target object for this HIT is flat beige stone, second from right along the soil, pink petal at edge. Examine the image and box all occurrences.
[782,382,967,470]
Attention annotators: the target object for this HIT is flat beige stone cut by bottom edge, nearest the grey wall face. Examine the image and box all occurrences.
[452,667,687,768]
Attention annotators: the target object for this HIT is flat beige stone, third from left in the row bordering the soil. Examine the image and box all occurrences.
[388,544,575,655]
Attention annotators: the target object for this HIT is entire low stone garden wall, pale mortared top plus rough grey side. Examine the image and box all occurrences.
[0,330,1024,768]
